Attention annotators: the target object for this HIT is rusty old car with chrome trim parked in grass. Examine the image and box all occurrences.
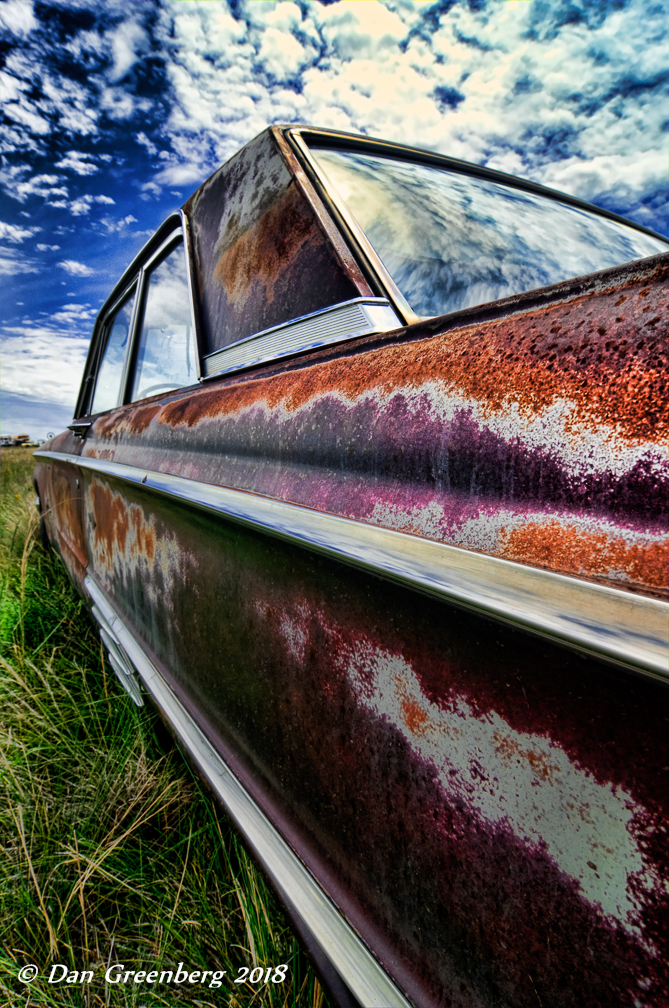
[35,126,669,1008]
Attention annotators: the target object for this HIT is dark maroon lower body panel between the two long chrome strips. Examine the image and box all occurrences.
[77,476,669,1008]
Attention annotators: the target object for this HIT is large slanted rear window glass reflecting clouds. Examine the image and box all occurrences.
[313,150,668,316]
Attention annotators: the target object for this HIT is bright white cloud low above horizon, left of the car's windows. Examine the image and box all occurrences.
[0,325,88,407]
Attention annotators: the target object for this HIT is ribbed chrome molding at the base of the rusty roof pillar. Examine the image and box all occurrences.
[203,297,404,378]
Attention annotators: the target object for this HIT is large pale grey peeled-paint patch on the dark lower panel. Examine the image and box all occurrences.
[339,645,648,953]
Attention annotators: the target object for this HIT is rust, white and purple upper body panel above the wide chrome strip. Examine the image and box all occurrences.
[84,256,669,597]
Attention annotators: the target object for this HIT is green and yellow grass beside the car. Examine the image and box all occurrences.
[0,449,325,1008]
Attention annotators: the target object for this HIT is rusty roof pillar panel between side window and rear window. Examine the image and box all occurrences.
[184,133,370,353]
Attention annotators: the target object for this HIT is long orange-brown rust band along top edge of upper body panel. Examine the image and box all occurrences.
[161,256,669,440]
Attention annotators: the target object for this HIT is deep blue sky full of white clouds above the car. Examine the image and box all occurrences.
[0,0,669,437]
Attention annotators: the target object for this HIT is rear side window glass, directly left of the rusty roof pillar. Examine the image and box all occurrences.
[131,244,197,401]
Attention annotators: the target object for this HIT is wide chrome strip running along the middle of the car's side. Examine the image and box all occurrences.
[34,451,669,682]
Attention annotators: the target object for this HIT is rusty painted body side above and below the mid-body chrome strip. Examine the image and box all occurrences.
[73,256,668,1008]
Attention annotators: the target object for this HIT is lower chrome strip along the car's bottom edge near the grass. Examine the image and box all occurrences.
[84,577,411,1008]
